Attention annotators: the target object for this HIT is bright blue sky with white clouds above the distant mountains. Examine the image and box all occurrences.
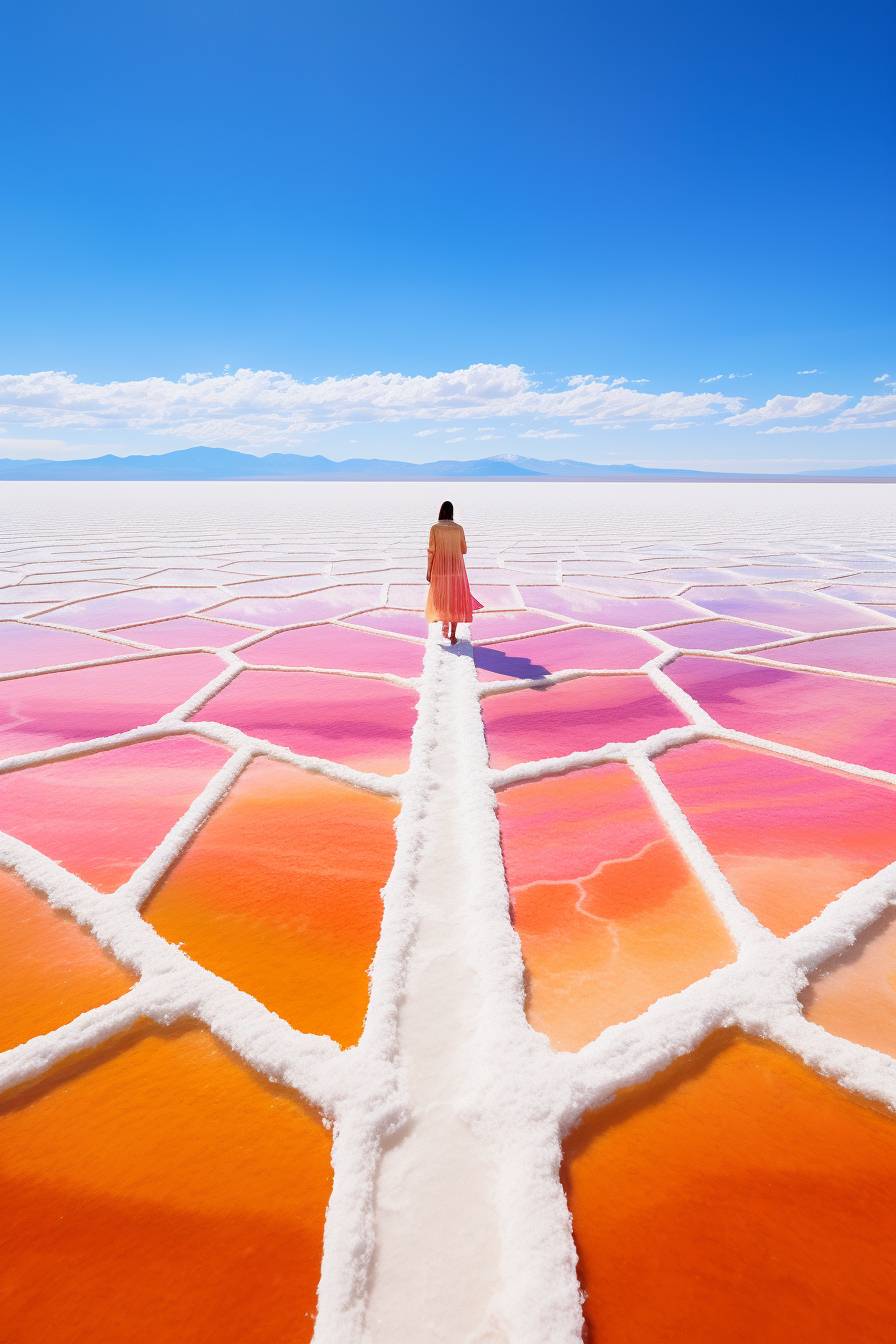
[0,0,896,469]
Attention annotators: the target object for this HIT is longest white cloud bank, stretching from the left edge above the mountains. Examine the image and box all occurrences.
[0,364,743,446]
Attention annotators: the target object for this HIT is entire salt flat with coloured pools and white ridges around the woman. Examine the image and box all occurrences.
[0,482,896,1344]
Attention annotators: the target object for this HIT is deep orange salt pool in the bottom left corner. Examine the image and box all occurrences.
[0,1025,330,1344]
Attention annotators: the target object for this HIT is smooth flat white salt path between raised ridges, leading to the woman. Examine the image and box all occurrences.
[365,639,506,1344]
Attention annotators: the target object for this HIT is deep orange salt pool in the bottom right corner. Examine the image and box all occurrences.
[564,1036,896,1344]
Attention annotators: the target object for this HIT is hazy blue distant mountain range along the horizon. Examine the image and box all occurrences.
[0,441,896,481]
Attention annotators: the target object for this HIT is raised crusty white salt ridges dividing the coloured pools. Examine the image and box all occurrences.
[0,508,896,1344]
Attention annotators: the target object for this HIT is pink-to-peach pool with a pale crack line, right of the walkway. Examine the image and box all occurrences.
[498,765,733,1050]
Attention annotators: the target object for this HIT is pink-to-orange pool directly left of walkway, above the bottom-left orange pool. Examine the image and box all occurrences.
[146,761,398,1046]
